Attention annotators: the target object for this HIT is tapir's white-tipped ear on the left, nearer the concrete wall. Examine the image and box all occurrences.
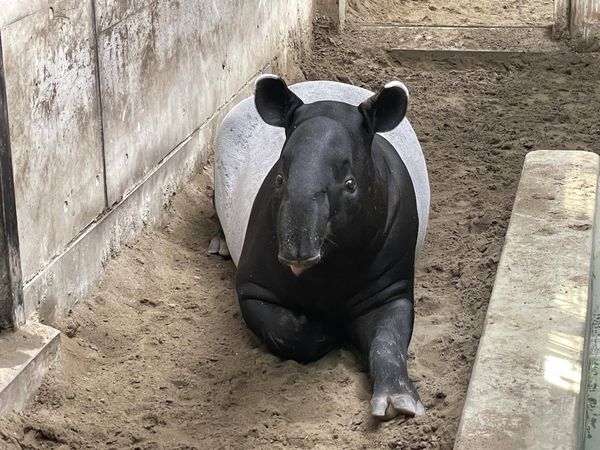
[254,75,303,127]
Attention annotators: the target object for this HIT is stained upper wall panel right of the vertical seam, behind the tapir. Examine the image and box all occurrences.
[98,0,310,205]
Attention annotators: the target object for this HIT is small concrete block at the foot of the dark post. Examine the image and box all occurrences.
[0,322,60,416]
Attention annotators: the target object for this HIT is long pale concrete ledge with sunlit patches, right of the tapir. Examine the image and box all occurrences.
[454,151,599,450]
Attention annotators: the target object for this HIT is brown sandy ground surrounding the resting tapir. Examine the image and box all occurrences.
[0,1,600,449]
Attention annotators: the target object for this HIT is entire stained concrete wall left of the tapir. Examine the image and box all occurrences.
[0,0,312,322]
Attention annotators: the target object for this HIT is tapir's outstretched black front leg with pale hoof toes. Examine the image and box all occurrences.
[352,299,425,420]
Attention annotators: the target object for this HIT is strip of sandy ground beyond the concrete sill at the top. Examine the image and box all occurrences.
[348,0,554,26]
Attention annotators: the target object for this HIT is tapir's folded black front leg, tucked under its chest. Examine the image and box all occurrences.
[240,299,339,363]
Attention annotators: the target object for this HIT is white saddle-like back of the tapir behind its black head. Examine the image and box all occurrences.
[215,81,429,264]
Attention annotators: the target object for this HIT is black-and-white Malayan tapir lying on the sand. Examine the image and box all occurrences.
[215,75,429,419]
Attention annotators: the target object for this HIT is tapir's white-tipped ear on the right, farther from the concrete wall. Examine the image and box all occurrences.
[358,81,408,133]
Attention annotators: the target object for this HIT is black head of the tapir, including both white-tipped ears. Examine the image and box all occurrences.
[255,75,408,276]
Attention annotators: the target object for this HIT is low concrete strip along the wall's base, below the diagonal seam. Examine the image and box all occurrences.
[24,74,258,324]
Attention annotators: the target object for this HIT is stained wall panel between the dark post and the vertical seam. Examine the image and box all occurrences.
[2,0,104,280]
